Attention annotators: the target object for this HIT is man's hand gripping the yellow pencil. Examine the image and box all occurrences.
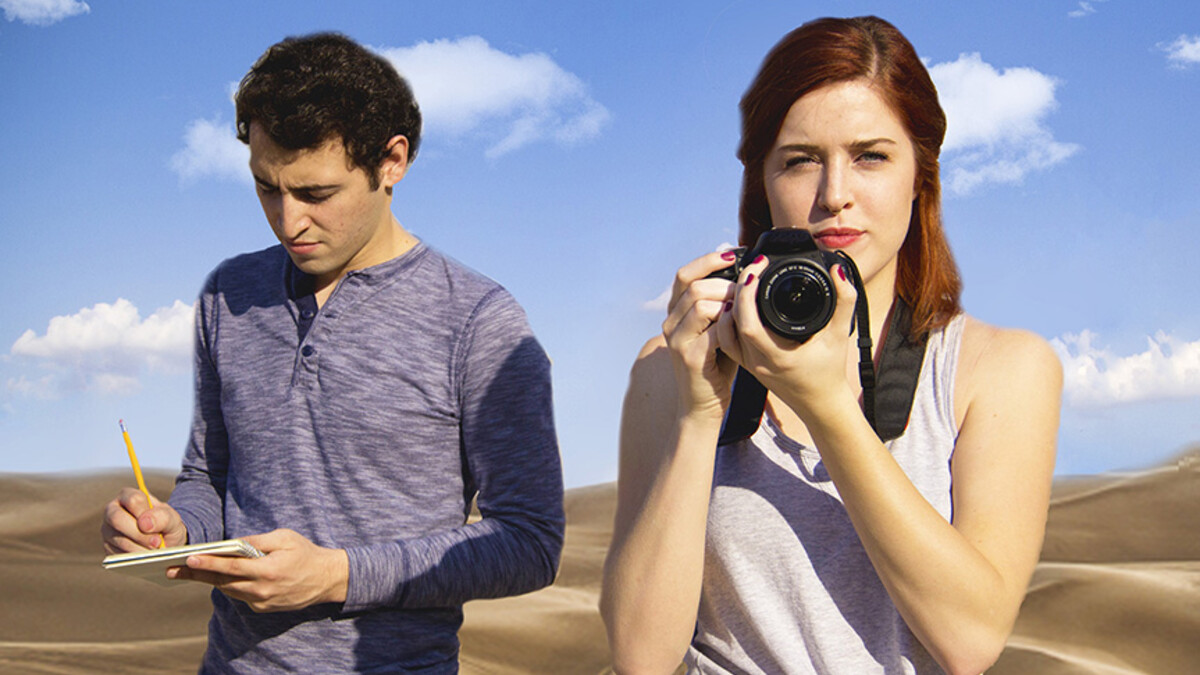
[100,488,187,554]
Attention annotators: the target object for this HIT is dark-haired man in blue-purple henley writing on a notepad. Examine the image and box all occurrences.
[103,34,564,673]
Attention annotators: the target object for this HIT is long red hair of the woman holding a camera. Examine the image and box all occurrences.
[738,17,962,336]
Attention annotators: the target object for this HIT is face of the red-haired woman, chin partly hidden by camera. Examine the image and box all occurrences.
[763,80,917,288]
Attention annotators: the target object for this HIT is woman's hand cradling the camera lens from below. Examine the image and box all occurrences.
[716,257,858,422]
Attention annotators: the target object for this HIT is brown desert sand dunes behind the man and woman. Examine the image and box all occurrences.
[0,448,1200,675]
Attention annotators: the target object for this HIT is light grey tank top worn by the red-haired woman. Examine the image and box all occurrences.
[685,315,964,674]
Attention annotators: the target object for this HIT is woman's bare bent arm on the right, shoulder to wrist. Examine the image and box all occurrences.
[808,319,1062,674]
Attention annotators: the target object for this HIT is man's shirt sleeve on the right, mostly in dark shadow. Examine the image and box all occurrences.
[346,289,564,611]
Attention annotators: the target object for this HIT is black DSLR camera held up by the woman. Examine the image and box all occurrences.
[708,228,859,342]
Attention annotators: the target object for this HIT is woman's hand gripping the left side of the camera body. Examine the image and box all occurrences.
[662,251,737,419]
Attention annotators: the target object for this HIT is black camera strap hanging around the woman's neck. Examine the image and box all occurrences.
[718,283,926,446]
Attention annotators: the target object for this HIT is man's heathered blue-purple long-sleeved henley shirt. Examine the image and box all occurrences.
[159,245,564,671]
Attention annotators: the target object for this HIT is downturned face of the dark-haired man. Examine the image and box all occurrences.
[250,123,407,292]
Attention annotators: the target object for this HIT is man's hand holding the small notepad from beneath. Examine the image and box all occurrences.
[174,530,350,611]
